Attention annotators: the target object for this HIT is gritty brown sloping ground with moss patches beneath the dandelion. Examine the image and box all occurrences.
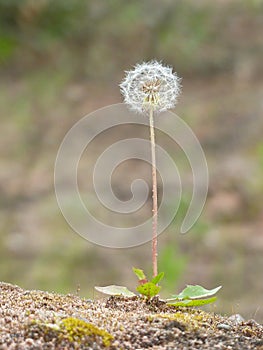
[0,283,263,350]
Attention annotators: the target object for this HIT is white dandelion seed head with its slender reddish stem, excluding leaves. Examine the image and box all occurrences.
[120,60,181,276]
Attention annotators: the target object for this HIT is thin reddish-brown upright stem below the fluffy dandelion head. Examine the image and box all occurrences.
[149,108,158,277]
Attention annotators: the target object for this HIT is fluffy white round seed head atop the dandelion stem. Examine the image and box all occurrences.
[120,61,181,113]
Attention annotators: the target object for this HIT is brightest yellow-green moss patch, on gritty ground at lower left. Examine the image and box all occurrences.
[61,317,113,346]
